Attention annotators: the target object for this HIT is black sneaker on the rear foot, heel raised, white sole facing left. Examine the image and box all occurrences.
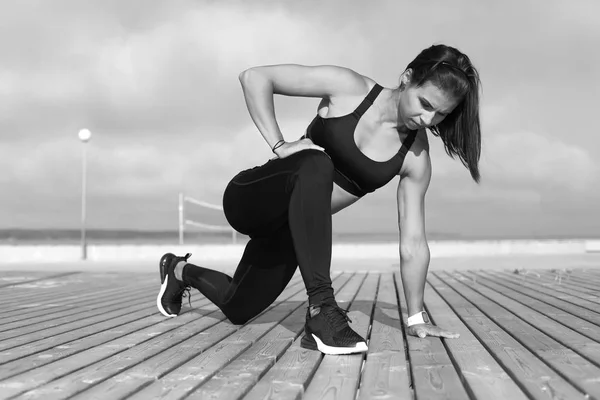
[156,253,192,317]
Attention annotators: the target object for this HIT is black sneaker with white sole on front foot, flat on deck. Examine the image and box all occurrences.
[300,303,367,354]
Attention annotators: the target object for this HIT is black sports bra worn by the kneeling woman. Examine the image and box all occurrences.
[305,84,417,197]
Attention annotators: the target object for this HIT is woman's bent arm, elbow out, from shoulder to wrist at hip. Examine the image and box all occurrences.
[239,64,367,156]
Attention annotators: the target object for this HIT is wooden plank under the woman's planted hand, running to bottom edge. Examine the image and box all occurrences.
[395,274,469,400]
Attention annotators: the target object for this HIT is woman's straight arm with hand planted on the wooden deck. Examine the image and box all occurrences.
[398,139,458,338]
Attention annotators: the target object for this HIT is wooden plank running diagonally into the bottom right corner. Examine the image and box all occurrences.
[436,273,600,396]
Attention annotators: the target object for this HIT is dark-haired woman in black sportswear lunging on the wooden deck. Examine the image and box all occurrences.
[157,45,481,354]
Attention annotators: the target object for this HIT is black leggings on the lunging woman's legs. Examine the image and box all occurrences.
[183,150,335,324]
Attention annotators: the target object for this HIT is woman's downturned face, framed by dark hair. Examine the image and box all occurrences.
[398,77,460,130]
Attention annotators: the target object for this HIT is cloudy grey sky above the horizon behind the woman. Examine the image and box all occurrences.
[0,0,600,237]
